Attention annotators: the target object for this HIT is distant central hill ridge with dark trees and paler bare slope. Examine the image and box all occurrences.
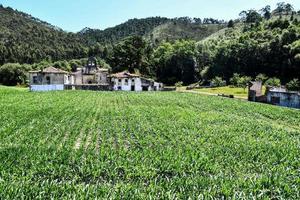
[78,17,226,44]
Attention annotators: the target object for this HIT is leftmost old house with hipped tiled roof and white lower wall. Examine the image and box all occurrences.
[29,67,74,91]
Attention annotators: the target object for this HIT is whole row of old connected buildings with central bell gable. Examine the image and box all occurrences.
[29,58,163,91]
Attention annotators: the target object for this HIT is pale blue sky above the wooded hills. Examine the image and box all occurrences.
[0,0,300,32]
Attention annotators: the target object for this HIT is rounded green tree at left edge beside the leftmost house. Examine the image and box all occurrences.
[0,63,31,86]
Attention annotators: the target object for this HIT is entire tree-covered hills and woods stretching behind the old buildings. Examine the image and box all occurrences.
[0,3,300,88]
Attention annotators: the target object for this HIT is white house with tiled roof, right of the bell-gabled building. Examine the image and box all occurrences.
[109,71,163,91]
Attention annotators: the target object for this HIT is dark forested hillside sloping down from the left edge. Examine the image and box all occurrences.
[0,5,87,64]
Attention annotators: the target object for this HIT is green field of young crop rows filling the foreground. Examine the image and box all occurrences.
[0,87,300,199]
